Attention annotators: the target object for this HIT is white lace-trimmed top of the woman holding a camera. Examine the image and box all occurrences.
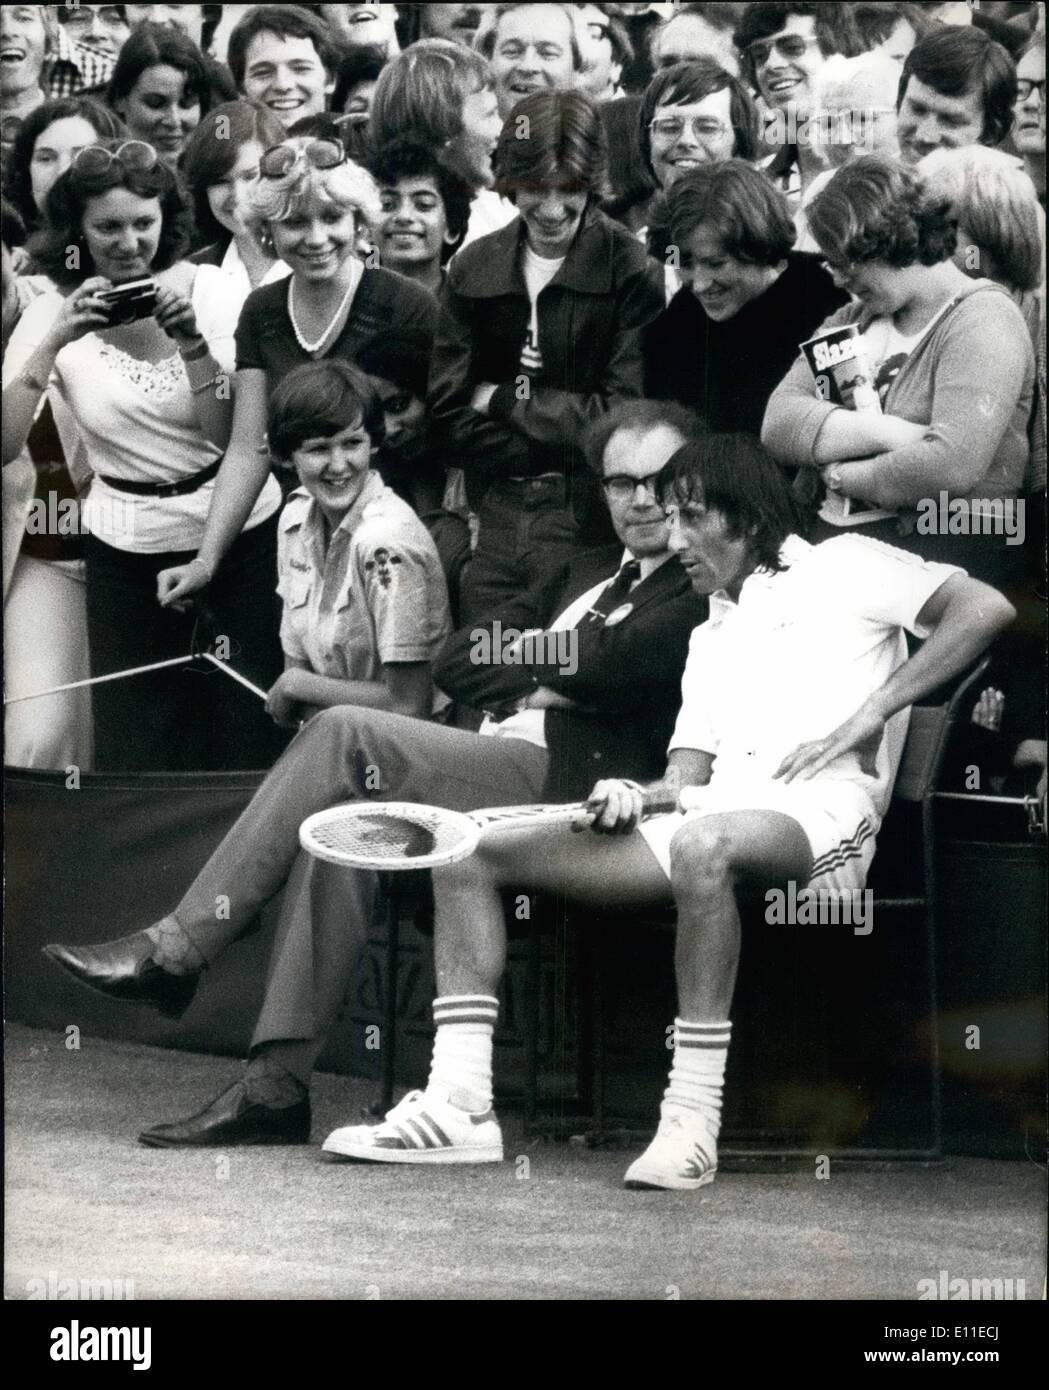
[4,284,281,553]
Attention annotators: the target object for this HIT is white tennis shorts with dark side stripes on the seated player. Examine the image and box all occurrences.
[638,777,879,892]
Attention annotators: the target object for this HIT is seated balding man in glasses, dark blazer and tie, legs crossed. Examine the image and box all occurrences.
[47,400,707,1148]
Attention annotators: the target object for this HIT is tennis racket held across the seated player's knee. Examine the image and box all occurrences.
[299,788,686,873]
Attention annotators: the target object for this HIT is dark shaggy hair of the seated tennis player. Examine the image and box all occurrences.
[656,434,803,573]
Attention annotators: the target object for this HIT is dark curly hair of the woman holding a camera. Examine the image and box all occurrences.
[29,140,193,289]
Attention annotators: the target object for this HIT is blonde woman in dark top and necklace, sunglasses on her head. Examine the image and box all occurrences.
[157,135,436,607]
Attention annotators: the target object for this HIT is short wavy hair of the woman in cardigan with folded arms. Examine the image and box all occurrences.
[809,154,957,270]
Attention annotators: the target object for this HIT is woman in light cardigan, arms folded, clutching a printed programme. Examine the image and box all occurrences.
[761,154,1035,588]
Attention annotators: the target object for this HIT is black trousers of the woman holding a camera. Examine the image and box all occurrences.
[85,516,288,771]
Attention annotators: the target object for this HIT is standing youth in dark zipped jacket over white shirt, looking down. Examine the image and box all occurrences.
[428,90,663,621]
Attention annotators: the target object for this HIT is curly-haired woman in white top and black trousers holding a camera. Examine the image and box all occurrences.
[3,140,281,770]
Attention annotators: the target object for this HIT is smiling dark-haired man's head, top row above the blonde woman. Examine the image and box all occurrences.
[229,4,336,126]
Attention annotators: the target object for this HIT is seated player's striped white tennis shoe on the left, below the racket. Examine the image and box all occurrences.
[322,1088,503,1163]
